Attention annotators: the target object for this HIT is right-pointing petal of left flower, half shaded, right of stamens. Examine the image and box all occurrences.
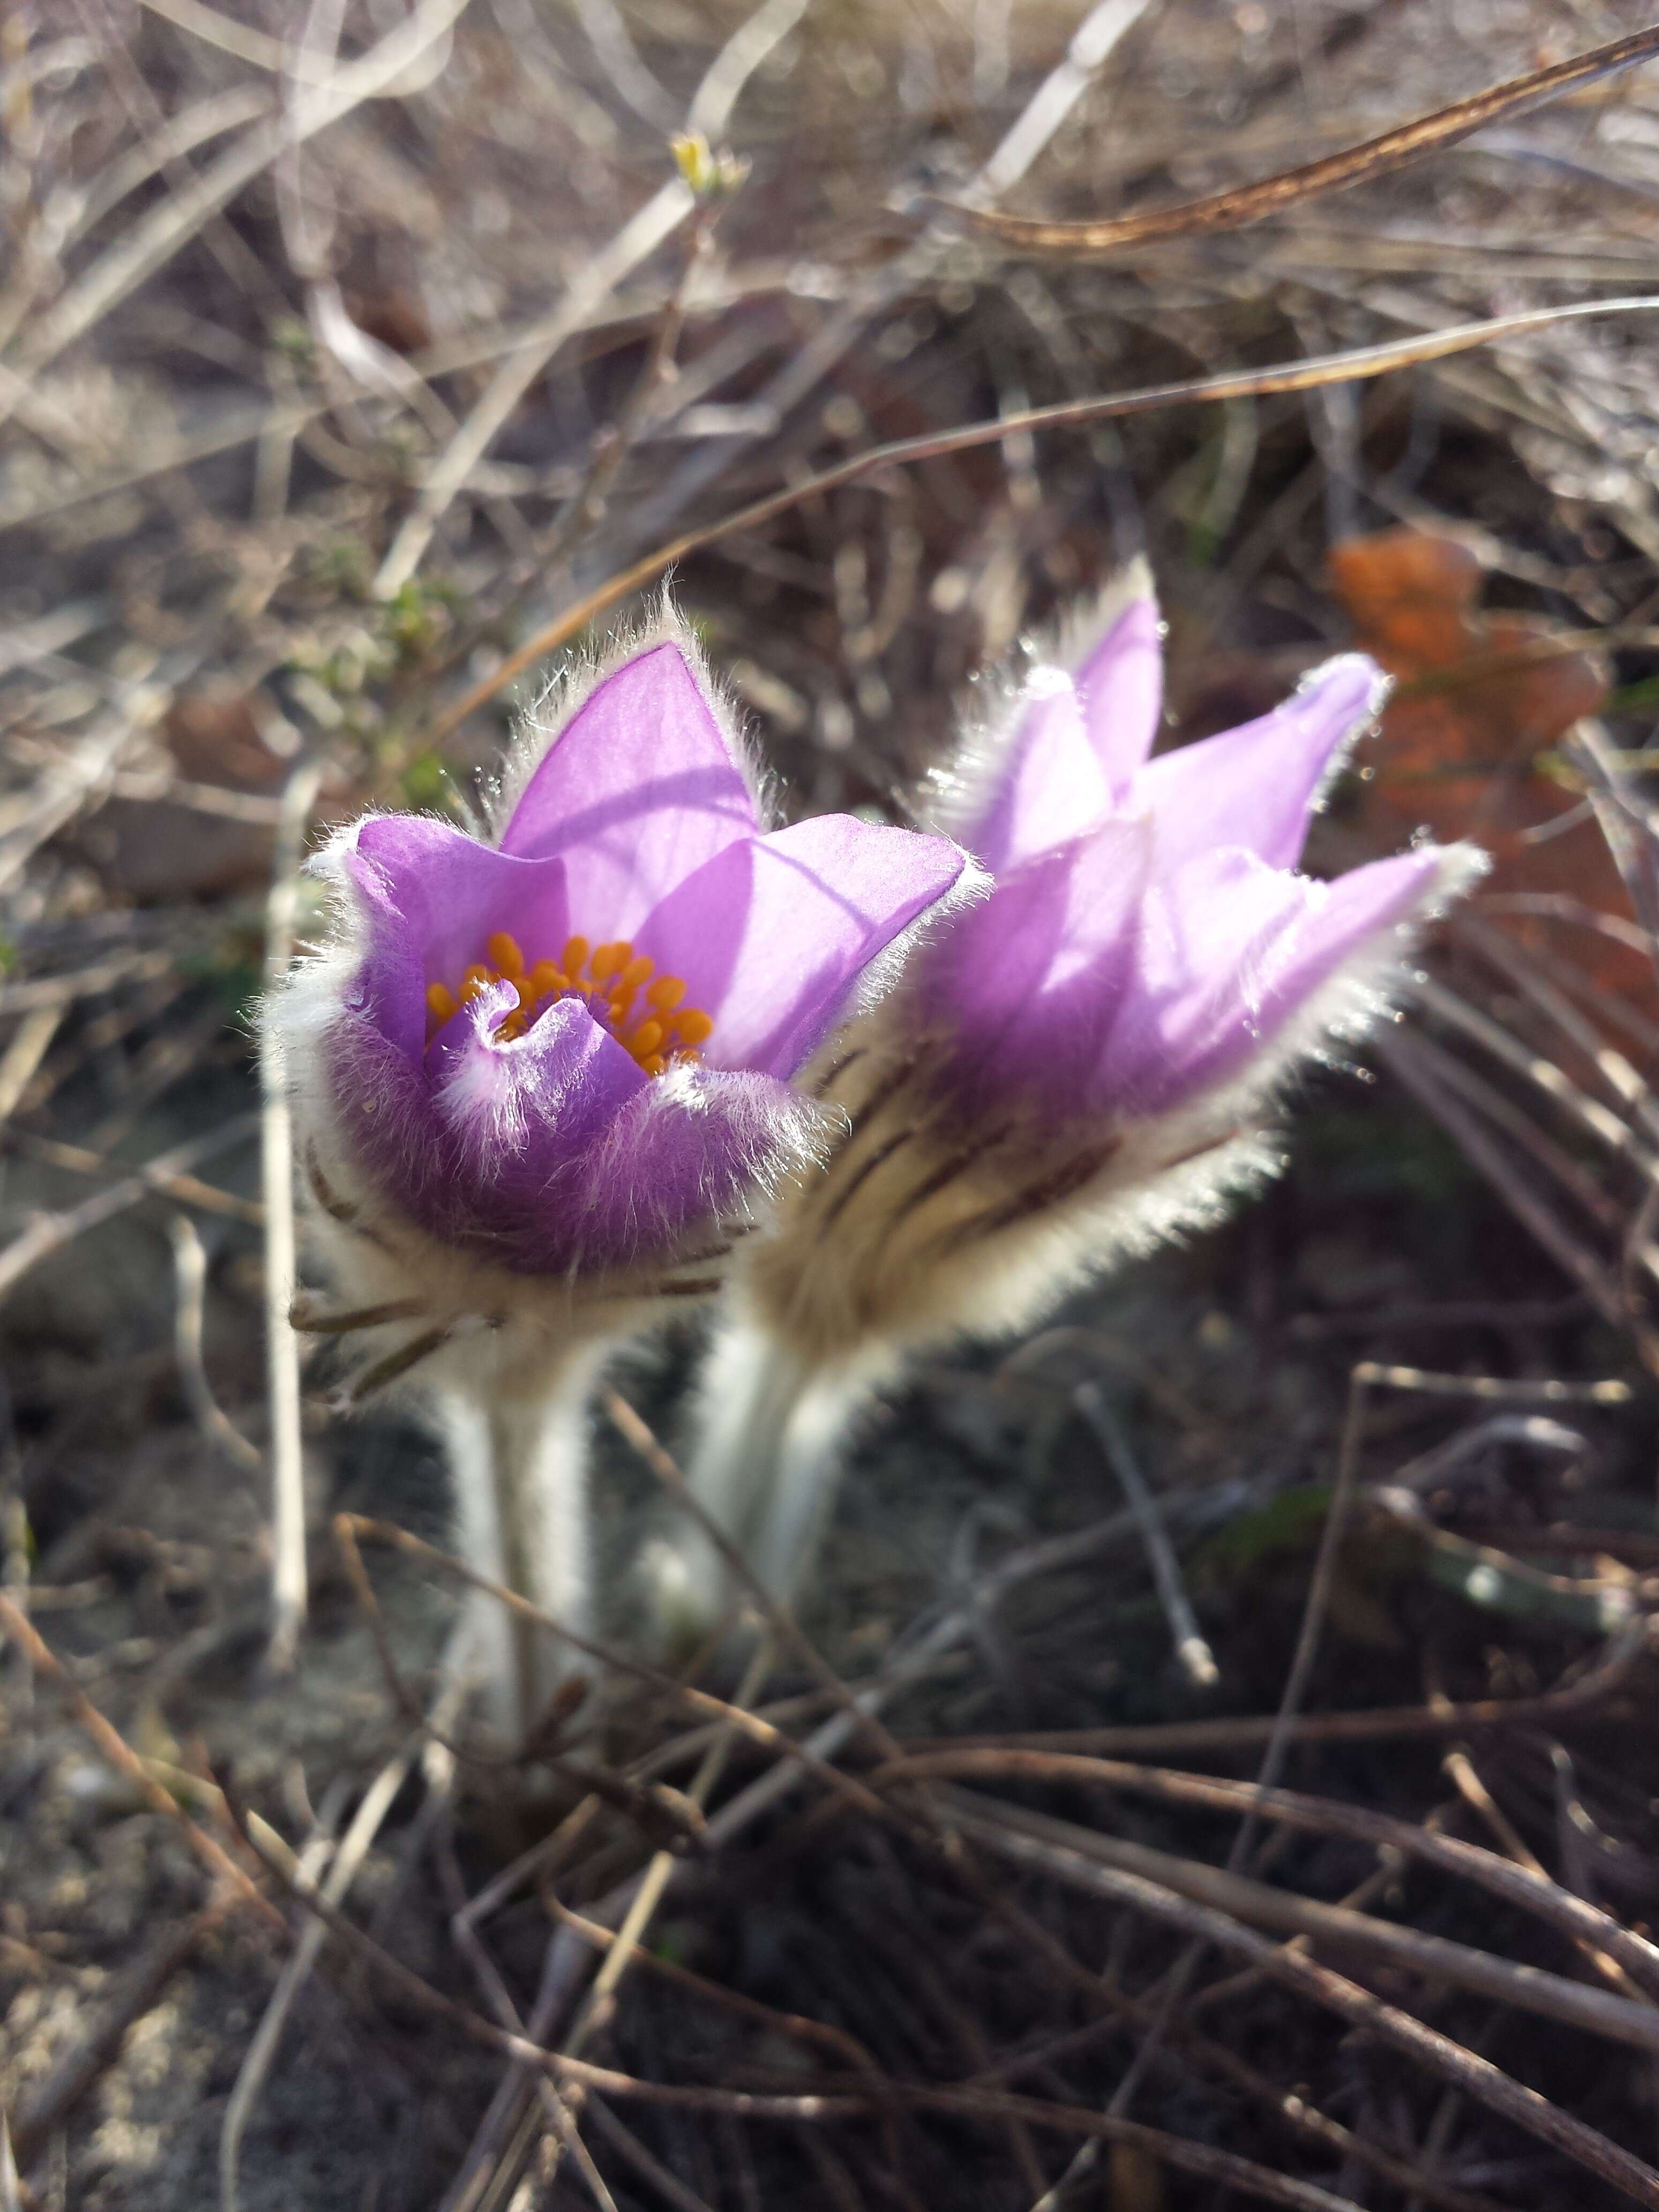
[635,814,965,1077]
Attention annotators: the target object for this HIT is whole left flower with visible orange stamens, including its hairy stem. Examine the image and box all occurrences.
[272,617,967,1725]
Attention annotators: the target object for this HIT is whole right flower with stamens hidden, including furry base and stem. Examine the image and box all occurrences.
[659,566,1484,1615]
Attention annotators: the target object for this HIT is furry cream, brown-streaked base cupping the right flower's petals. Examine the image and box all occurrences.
[743,845,1486,1363]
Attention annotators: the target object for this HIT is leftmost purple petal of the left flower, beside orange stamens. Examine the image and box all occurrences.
[345,814,571,1066]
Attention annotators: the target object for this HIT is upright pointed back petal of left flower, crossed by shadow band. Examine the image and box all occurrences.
[500,644,757,943]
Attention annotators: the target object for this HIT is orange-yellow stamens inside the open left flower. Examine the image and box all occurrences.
[427,929,714,1075]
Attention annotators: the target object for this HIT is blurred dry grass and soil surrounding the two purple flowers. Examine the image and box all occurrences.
[0,0,1659,2212]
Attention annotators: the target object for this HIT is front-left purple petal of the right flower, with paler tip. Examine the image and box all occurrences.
[920,816,1153,1115]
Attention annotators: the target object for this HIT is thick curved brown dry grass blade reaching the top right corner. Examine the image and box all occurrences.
[945,24,1659,259]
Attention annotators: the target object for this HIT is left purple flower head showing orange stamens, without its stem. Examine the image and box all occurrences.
[279,622,967,1281]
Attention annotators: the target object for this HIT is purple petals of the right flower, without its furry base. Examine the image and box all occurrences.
[918,564,1484,1122]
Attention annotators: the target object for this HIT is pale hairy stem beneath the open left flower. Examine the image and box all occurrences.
[436,1341,608,1747]
